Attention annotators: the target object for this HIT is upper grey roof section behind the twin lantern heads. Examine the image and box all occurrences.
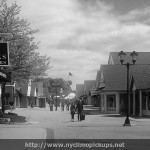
[108,52,150,64]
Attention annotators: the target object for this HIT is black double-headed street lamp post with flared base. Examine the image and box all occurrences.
[118,51,138,126]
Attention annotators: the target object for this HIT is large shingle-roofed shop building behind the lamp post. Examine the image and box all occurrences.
[96,52,150,116]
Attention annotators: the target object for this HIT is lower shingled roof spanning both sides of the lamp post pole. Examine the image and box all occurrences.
[99,64,150,91]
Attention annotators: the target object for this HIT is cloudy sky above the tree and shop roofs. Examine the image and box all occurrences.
[8,0,150,90]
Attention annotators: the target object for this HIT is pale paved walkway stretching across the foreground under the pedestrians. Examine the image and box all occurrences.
[0,107,150,139]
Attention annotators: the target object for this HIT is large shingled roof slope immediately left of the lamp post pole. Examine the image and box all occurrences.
[99,65,127,91]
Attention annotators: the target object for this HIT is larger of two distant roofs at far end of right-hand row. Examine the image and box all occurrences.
[84,80,96,95]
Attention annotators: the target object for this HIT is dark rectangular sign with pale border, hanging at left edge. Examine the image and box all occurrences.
[0,42,9,66]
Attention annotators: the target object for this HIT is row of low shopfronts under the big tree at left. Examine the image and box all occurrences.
[1,80,46,110]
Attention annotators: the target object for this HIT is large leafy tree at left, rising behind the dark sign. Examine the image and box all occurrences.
[0,0,50,112]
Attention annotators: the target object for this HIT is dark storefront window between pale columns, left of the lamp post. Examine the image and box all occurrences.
[107,95,116,111]
